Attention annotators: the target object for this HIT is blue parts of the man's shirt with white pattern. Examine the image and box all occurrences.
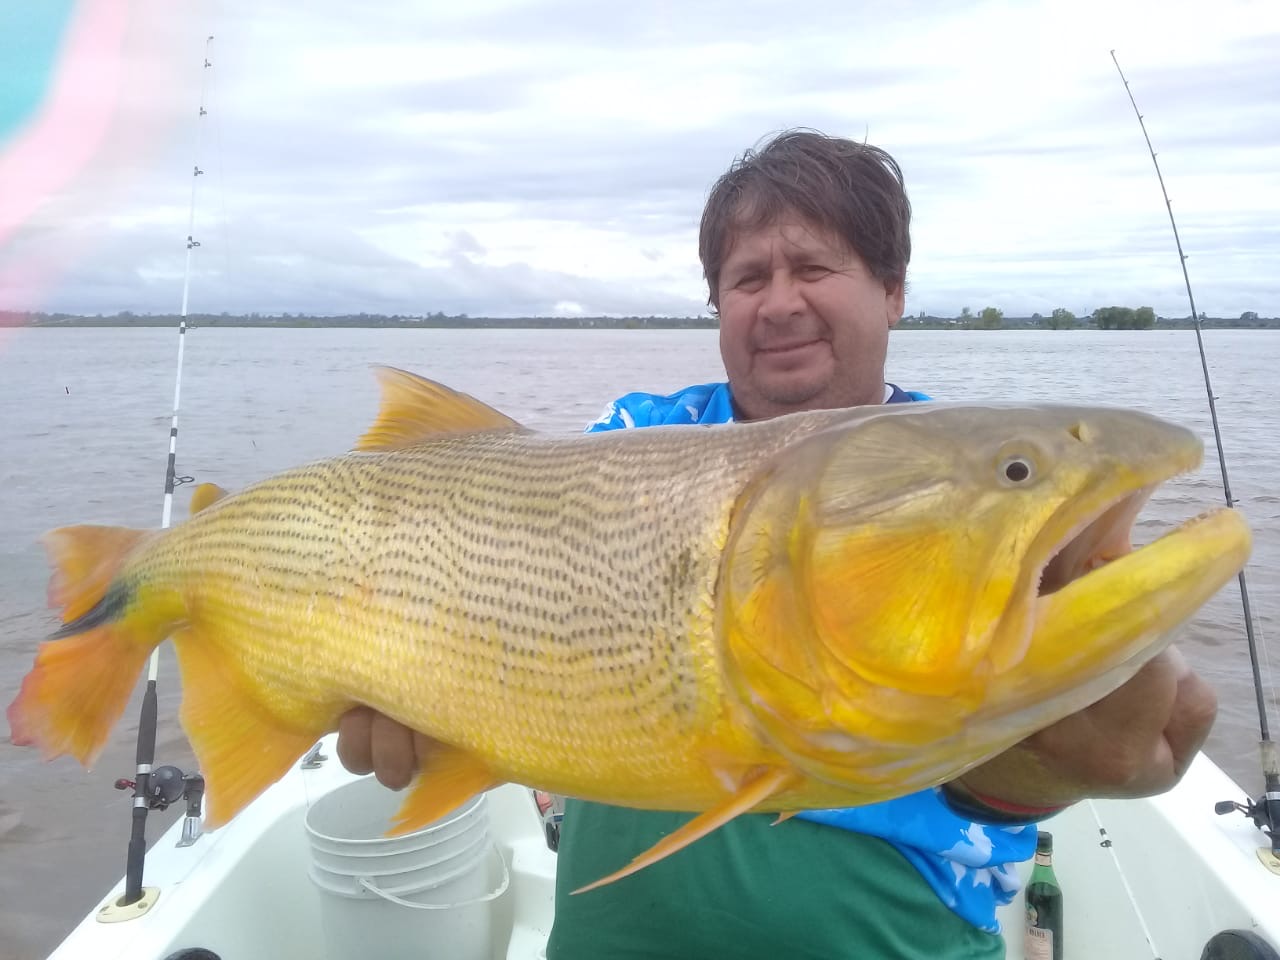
[586,383,1037,933]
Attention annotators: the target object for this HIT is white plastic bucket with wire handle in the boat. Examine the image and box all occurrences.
[306,777,511,960]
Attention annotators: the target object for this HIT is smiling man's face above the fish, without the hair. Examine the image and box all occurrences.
[719,216,902,420]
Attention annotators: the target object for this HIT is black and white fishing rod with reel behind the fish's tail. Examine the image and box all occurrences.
[116,36,214,908]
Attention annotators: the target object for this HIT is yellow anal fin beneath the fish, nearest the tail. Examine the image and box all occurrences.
[173,627,325,829]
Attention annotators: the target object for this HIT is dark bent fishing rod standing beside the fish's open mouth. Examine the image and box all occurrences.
[1111,50,1280,856]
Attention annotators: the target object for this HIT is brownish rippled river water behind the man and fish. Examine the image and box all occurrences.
[0,329,1280,960]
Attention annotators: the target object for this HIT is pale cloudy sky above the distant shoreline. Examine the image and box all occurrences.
[0,0,1280,317]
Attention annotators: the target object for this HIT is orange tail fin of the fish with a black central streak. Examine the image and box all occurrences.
[8,526,173,767]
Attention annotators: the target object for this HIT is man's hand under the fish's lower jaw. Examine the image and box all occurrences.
[957,648,1217,808]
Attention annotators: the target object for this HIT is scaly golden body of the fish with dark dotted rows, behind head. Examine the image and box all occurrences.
[134,415,836,804]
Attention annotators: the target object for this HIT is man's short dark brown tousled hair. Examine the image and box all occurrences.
[698,129,911,310]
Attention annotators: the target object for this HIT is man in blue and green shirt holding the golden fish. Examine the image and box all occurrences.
[339,131,1216,960]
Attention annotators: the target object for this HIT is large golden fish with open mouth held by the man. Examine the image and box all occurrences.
[9,369,1249,877]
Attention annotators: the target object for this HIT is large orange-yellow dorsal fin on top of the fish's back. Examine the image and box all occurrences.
[355,366,525,451]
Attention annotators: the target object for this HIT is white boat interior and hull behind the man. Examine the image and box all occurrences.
[51,739,1280,960]
